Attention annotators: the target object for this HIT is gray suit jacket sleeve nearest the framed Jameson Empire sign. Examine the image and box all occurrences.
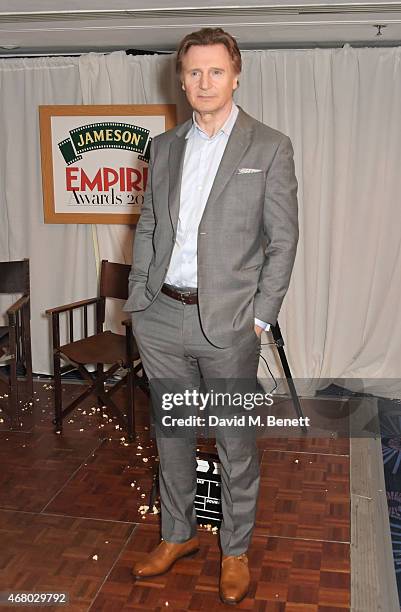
[128,140,155,295]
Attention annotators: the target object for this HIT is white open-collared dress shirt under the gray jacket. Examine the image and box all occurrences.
[165,103,270,329]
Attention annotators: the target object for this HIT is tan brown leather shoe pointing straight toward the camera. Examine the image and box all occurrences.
[220,553,249,605]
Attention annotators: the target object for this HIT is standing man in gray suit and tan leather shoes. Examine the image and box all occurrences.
[125,28,298,604]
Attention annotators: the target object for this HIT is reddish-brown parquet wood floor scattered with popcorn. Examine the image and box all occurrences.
[0,382,350,612]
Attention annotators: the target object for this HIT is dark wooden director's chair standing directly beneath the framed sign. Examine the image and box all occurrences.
[46,260,147,442]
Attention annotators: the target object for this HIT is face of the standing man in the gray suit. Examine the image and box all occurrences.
[181,44,238,113]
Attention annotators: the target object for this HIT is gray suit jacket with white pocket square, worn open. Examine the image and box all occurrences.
[124,109,298,347]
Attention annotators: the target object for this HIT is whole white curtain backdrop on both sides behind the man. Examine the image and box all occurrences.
[0,45,401,395]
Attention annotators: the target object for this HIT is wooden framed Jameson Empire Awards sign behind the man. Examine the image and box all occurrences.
[39,104,176,224]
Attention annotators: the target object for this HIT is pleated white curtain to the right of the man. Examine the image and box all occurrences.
[238,45,401,396]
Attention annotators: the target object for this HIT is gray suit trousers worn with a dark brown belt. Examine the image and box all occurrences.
[132,293,260,555]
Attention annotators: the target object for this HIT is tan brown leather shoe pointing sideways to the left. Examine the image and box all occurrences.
[132,536,199,579]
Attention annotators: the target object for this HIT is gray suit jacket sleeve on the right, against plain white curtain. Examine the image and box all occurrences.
[254,136,298,325]
